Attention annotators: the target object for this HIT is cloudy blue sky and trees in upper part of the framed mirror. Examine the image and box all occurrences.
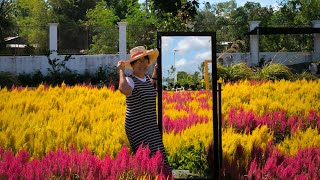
[161,36,212,91]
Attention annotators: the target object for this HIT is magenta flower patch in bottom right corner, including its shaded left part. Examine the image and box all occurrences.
[207,141,320,180]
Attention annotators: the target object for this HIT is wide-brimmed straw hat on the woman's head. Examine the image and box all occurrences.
[125,46,159,69]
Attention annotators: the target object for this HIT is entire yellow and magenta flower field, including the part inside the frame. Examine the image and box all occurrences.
[0,80,320,179]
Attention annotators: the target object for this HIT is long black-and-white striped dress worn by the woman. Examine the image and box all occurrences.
[125,75,169,167]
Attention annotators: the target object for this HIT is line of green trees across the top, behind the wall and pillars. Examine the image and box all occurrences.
[0,0,320,54]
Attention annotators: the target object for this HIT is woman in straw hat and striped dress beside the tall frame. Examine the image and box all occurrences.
[117,46,170,173]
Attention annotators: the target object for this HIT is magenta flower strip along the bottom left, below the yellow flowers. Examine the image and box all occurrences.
[0,146,171,180]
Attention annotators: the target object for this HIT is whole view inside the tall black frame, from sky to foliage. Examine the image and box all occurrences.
[158,33,217,174]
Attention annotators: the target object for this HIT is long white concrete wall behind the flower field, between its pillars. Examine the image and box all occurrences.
[0,52,320,75]
